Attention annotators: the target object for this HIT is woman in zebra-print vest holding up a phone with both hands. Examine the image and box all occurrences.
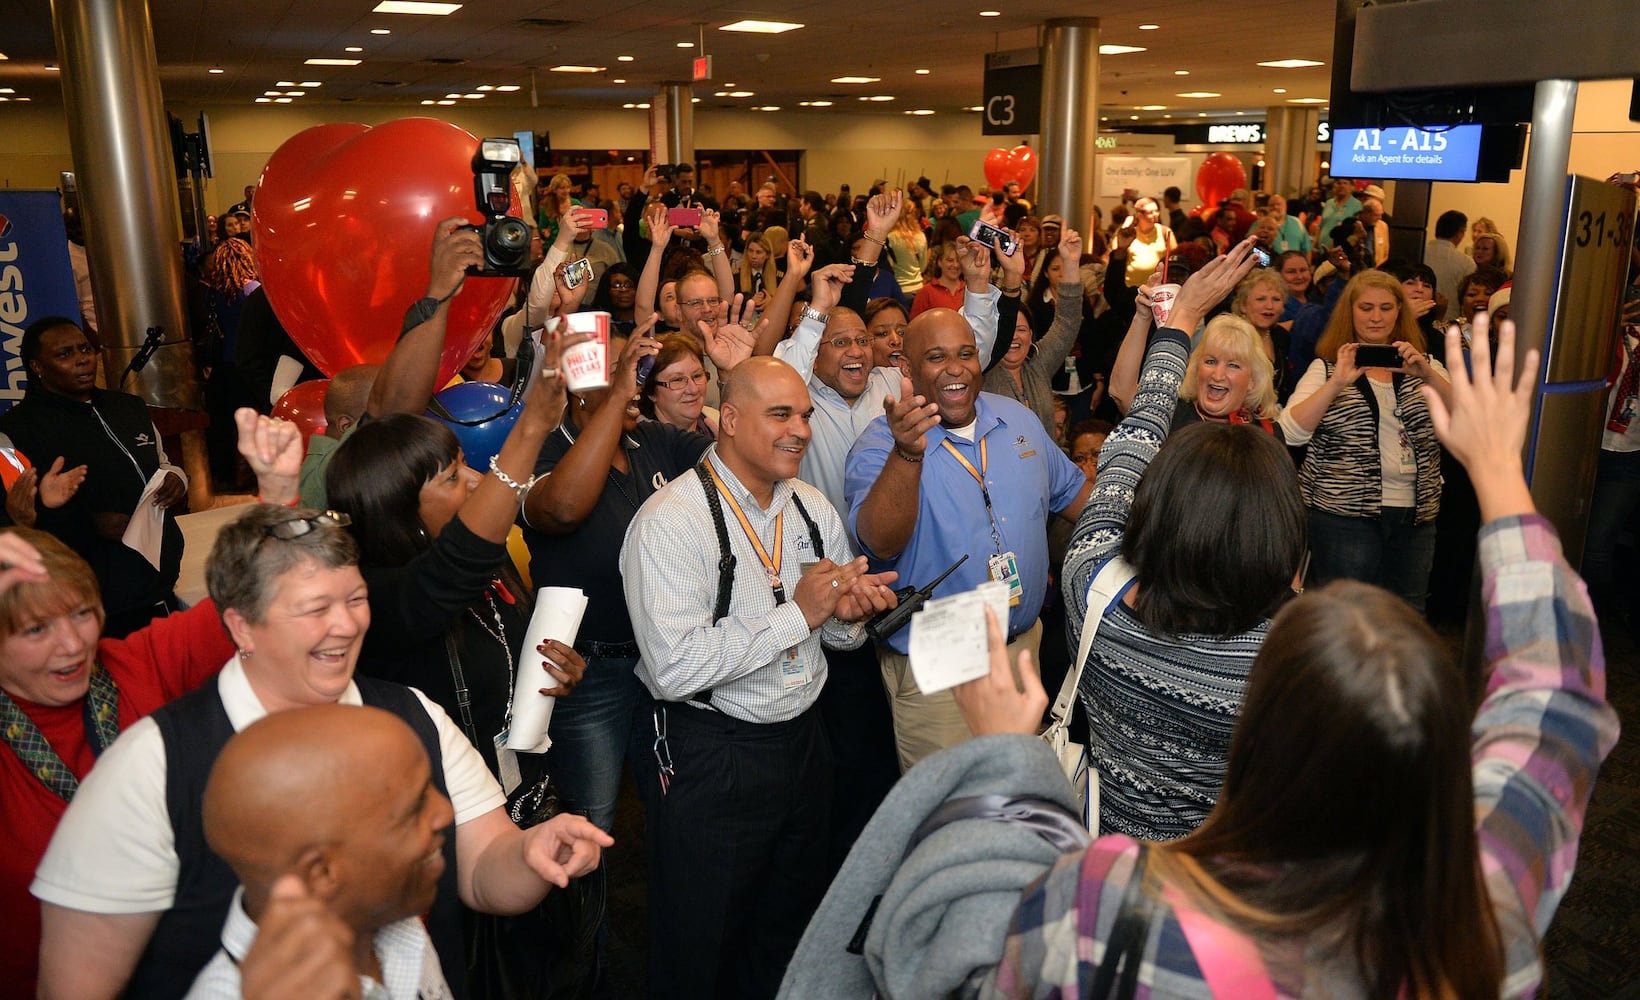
[1281,270,1451,611]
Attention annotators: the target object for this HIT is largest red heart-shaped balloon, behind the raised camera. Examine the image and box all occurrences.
[253,118,517,381]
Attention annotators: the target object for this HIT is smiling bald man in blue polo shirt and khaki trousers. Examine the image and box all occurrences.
[845,308,1092,769]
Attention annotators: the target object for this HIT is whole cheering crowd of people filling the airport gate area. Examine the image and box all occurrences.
[0,157,1640,998]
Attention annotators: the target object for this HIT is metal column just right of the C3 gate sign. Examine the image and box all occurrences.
[1035,18,1099,238]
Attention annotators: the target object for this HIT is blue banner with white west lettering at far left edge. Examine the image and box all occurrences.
[0,190,80,411]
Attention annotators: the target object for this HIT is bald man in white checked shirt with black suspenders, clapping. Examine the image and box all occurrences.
[622,354,898,998]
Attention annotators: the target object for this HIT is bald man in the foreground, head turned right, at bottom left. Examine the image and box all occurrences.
[189,705,459,1000]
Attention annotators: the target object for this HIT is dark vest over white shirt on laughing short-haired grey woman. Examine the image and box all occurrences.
[123,677,466,1000]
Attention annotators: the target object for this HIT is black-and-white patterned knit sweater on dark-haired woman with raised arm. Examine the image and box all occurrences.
[1061,322,1269,841]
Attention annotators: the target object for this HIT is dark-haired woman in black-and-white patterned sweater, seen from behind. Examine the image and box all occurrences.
[1061,243,1304,839]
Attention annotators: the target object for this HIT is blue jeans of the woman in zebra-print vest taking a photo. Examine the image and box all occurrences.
[1309,507,1435,613]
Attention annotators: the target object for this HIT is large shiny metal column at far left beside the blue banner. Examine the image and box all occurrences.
[51,0,200,410]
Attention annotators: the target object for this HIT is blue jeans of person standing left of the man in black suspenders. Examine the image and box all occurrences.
[546,656,653,833]
